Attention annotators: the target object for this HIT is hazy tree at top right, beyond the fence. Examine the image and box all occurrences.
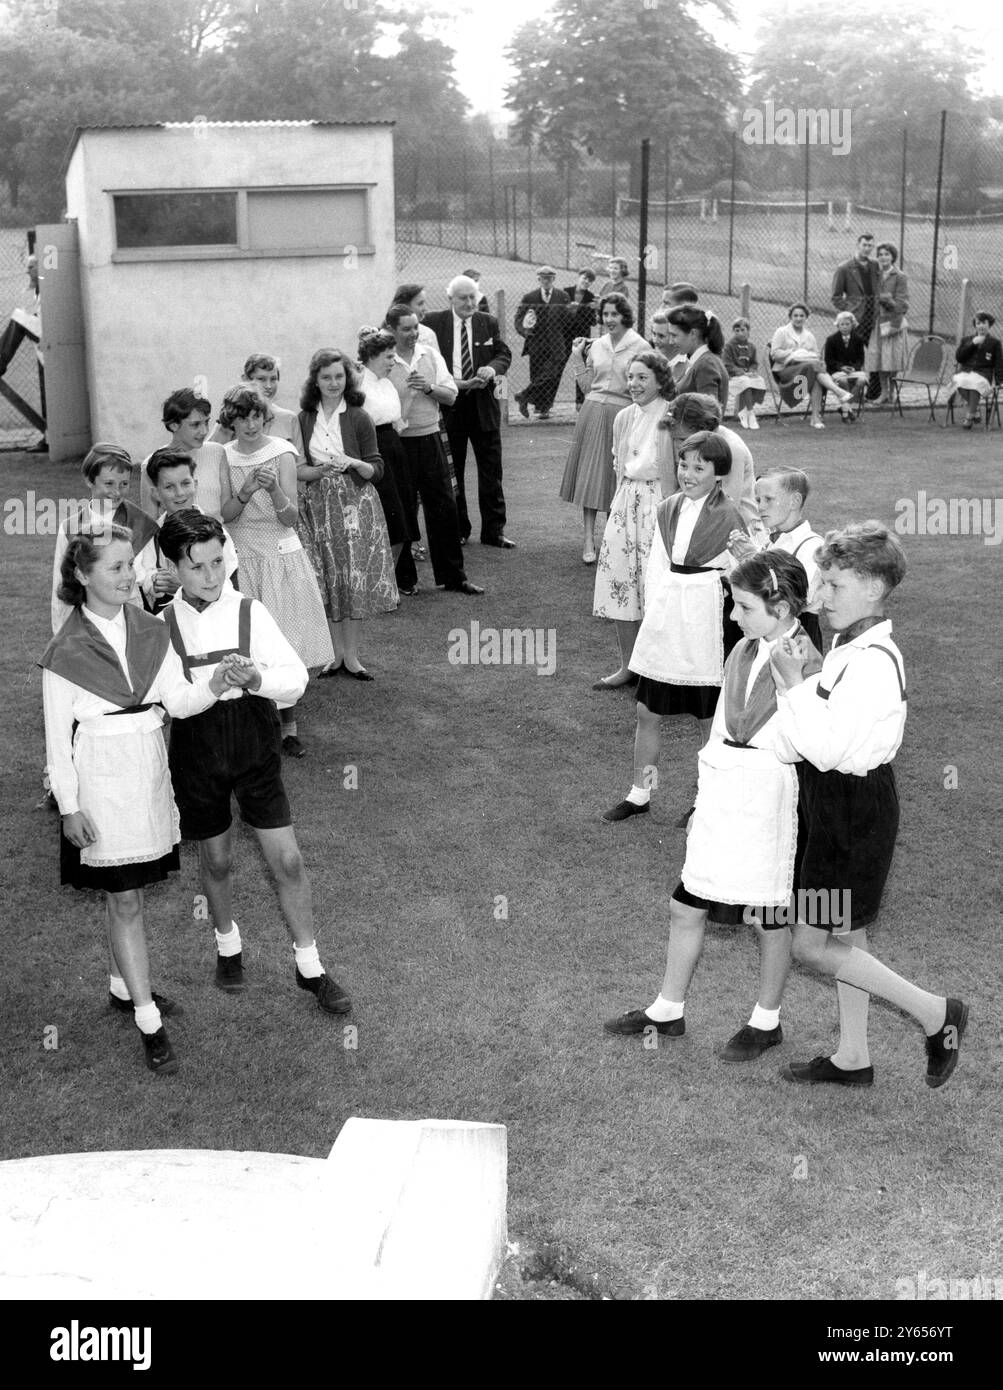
[746,0,985,202]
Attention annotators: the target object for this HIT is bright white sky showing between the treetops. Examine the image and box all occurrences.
[438,0,1003,114]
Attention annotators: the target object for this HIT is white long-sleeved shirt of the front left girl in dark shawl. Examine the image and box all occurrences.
[42,607,215,816]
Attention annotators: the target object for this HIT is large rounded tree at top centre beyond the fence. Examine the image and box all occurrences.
[506,0,739,183]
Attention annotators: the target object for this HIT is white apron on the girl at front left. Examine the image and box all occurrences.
[74,709,181,869]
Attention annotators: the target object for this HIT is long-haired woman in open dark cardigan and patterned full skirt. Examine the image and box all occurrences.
[297,348,400,681]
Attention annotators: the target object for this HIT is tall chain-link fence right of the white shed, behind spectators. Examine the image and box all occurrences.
[396,103,1003,404]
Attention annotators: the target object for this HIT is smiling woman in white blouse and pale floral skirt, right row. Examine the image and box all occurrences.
[592,352,675,689]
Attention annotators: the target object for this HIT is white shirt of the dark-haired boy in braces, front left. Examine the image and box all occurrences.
[161,585,308,709]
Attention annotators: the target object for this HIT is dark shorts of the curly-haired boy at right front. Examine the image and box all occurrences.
[797,763,899,931]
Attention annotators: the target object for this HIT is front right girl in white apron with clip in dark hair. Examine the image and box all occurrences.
[606,550,821,1062]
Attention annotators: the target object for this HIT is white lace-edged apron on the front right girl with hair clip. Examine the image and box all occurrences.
[682,733,797,908]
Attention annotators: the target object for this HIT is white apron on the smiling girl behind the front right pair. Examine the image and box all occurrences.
[631,525,724,686]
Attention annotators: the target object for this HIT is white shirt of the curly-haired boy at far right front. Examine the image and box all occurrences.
[777,619,906,777]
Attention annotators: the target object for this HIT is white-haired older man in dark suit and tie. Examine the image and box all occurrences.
[425,275,515,550]
